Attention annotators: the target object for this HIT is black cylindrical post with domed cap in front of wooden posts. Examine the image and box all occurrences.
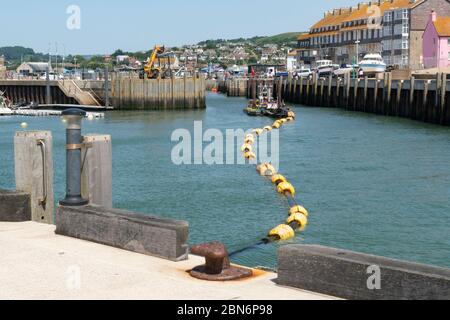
[59,109,89,207]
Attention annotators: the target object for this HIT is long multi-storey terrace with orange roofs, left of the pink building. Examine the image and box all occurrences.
[298,0,450,69]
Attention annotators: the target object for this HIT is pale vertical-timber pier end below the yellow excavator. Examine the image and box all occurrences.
[111,76,206,110]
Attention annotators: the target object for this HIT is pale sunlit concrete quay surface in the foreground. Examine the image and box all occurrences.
[0,222,335,300]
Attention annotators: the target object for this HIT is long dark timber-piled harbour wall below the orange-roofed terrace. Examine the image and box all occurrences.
[274,73,450,126]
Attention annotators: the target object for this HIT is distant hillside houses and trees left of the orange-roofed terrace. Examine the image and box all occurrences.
[0,32,301,78]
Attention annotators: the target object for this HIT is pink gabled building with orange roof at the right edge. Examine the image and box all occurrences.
[423,11,450,69]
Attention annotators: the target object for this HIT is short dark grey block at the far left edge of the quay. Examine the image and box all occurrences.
[0,189,31,222]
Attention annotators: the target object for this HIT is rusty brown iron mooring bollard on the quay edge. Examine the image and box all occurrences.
[191,242,253,281]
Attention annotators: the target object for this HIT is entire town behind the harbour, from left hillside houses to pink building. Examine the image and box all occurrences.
[0,0,450,80]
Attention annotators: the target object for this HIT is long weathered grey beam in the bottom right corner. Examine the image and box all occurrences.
[277,245,450,300]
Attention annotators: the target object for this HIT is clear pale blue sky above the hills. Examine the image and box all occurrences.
[0,0,357,55]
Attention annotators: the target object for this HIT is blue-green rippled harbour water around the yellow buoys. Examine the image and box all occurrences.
[0,95,450,267]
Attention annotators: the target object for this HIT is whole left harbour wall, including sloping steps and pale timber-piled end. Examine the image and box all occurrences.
[0,74,206,110]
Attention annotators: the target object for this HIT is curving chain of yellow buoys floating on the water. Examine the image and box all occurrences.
[241,112,309,243]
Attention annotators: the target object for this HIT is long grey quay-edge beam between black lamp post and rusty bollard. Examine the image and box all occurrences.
[56,205,189,261]
